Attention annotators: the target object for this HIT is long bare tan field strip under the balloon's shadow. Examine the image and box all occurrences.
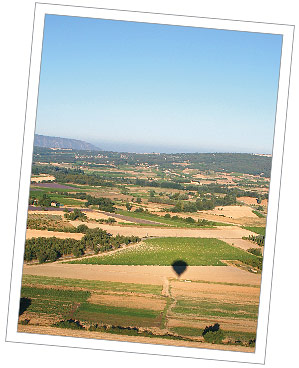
[23,262,261,286]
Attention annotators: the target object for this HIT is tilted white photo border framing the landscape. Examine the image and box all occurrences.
[6,3,294,364]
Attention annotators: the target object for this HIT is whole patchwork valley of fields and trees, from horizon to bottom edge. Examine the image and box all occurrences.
[18,148,271,352]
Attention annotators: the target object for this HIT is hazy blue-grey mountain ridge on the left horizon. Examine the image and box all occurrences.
[34,134,101,151]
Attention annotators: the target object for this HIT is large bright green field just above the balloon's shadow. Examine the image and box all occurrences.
[67,238,258,266]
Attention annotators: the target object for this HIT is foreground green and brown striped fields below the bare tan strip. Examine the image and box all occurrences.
[19,275,259,351]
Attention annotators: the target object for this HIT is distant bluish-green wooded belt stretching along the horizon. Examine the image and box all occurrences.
[33,147,272,177]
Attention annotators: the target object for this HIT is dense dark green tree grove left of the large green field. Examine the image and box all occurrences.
[24,229,140,263]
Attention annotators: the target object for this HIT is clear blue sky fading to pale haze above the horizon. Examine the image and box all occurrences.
[36,15,282,153]
